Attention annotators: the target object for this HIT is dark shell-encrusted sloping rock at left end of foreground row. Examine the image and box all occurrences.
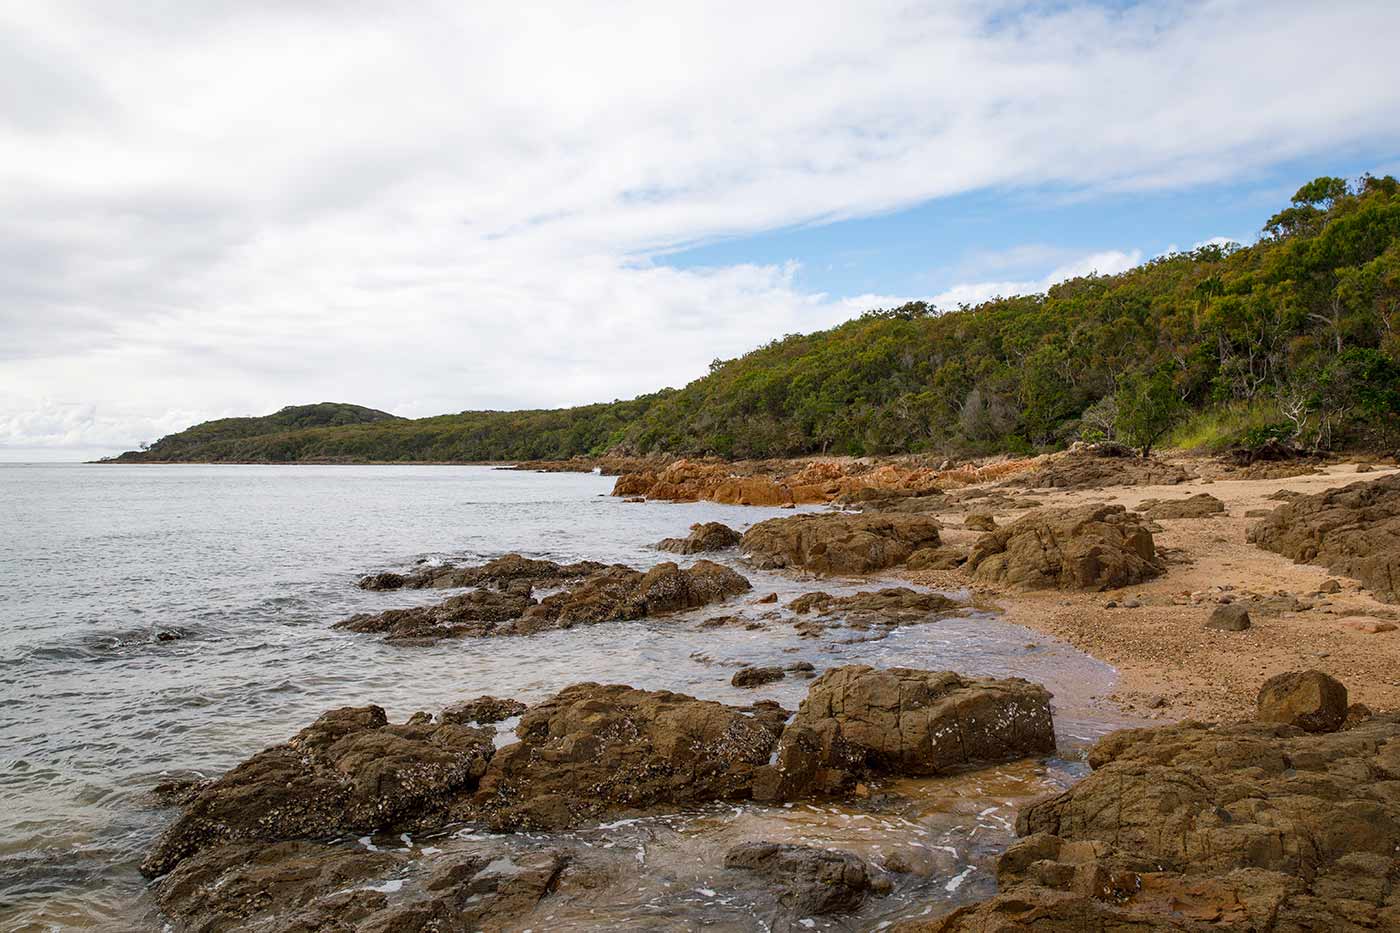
[141,706,494,877]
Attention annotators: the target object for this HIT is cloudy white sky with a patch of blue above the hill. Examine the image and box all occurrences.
[0,0,1400,461]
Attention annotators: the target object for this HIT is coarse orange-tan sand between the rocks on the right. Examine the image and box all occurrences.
[907,459,1400,720]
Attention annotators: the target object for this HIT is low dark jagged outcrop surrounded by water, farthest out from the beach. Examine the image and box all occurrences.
[335,560,752,643]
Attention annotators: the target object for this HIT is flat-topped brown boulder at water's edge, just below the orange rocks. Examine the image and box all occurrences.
[742,513,939,574]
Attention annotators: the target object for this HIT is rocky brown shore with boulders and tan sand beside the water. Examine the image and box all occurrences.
[38,447,1400,933]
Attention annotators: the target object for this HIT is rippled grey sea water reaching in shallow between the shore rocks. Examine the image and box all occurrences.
[0,465,1114,929]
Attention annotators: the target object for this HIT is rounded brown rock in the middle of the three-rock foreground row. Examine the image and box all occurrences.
[467,684,787,829]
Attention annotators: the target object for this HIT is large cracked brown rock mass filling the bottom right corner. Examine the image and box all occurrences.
[896,706,1400,933]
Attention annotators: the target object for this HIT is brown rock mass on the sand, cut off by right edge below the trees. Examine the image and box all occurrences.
[1247,474,1400,602]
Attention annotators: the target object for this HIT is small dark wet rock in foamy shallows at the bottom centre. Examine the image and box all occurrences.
[724,842,872,918]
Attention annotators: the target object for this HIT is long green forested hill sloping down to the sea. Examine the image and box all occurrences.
[119,175,1400,462]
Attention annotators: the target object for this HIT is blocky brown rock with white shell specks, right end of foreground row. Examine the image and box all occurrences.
[753,665,1054,800]
